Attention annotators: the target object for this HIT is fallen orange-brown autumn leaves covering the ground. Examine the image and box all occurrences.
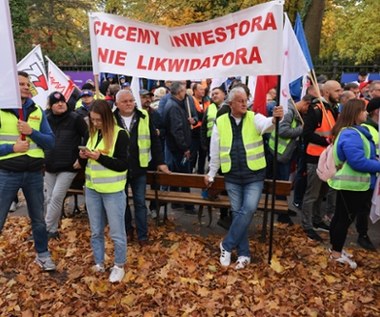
[0,217,380,317]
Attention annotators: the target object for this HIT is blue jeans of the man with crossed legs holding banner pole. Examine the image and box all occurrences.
[223,181,264,257]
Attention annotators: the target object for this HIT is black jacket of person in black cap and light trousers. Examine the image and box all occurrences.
[45,110,88,173]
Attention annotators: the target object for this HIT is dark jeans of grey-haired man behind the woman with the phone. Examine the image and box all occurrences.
[125,174,148,240]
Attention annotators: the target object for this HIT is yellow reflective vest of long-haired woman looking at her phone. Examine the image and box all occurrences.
[86,125,127,193]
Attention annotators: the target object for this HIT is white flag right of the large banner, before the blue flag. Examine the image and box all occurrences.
[280,14,310,113]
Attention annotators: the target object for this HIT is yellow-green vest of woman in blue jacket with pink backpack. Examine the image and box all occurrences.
[327,128,371,191]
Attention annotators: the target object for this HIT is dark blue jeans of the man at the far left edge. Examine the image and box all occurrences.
[0,169,50,257]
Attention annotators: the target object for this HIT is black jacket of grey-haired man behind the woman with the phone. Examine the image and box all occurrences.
[114,108,164,177]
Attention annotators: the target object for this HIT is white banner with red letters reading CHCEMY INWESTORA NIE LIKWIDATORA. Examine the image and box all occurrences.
[89,0,283,80]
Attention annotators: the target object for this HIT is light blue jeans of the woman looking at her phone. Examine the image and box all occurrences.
[85,187,127,266]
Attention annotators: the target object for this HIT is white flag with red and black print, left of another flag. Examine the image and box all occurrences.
[17,45,49,109]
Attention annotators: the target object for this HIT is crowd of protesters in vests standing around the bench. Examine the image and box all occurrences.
[0,72,380,282]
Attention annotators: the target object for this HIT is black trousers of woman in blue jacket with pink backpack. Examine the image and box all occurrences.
[330,190,372,252]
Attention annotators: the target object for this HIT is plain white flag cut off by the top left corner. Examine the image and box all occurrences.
[0,0,21,108]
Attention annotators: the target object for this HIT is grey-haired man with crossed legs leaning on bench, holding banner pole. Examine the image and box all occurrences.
[205,87,283,270]
